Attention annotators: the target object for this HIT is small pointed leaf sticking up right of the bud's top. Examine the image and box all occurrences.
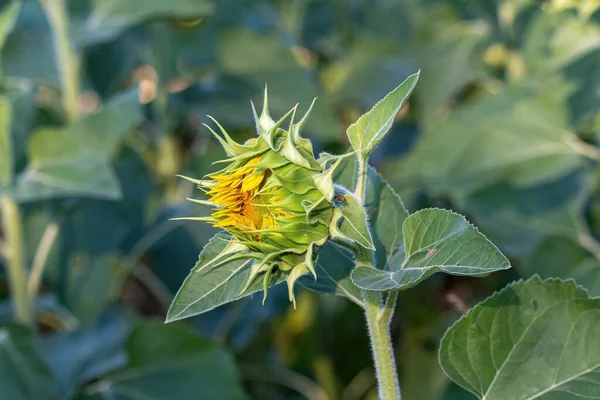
[347,72,419,157]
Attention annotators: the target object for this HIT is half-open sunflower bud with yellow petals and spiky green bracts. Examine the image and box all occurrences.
[179,90,339,301]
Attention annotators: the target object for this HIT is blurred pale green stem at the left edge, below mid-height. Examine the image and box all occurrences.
[1,196,33,327]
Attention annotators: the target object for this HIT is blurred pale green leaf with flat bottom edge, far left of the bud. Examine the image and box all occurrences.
[13,128,121,202]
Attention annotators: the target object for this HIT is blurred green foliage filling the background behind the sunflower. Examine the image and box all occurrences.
[0,0,600,400]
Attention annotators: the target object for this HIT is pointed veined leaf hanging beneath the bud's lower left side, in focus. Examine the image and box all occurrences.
[166,233,282,322]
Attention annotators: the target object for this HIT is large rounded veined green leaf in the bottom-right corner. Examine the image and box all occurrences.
[440,276,600,400]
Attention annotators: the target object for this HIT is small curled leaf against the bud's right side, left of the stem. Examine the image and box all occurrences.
[330,187,375,250]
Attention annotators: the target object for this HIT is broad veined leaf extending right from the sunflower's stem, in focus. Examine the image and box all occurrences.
[352,209,510,291]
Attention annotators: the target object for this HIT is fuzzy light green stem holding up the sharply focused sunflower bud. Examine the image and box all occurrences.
[356,156,401,400]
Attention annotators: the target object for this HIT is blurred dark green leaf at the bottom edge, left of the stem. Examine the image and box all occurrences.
[84,322,246,400]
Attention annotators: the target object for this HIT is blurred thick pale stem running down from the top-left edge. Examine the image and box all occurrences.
[40,0,80,121]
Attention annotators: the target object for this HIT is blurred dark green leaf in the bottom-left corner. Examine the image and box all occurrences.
[0,325,58,400]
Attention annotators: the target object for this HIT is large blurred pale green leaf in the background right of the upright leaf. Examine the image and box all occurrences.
[394,81,584,194]
